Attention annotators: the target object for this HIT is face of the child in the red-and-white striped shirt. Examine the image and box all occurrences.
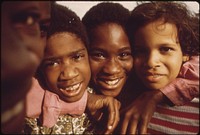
[134,20,183,89]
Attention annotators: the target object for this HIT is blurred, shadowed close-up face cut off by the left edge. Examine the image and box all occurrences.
[1,1,50,133]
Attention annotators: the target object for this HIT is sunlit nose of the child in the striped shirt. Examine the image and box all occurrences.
[144,52,160,68]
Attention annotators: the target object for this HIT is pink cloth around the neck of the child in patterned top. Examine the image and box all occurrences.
[26,79,87,127]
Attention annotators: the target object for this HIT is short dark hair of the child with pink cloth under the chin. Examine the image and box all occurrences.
[47,3,88,47]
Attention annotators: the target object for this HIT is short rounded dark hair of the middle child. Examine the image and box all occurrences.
[82,2,130,46]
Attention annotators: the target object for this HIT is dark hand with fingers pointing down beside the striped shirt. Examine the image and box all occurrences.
[120,90,165,134]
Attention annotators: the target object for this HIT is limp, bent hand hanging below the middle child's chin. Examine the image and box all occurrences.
[87,93,121,134]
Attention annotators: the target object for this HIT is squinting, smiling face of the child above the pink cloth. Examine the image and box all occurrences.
[43,32,91,102]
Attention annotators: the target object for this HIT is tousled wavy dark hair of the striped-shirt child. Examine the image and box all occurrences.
[128,1,199,56]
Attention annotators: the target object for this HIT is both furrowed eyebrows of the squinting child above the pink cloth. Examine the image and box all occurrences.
[43,48,86,61]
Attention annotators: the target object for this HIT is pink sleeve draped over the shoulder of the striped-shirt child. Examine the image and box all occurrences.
[161,56,199,106]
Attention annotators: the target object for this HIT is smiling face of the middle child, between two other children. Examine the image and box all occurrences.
[90,23,133,97]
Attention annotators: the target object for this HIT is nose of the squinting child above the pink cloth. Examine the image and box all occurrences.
[60,63,78,80]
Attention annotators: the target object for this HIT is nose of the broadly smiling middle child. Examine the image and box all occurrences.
[103,58,121,75]
